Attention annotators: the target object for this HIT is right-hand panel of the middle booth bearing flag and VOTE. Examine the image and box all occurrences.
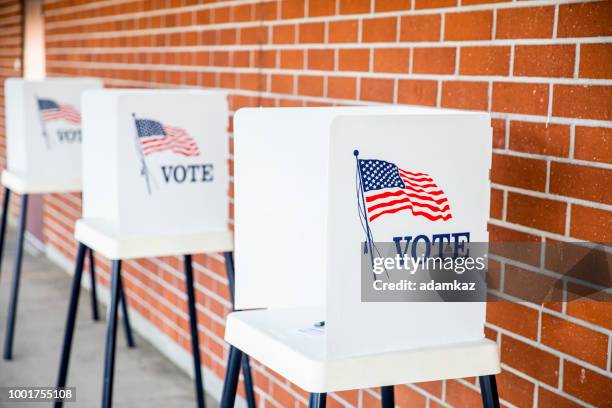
[116,91,229,237]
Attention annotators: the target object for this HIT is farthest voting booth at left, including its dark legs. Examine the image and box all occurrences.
[0,78,102,360]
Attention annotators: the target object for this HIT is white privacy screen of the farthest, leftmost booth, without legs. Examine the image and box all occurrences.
[4,78,102,190]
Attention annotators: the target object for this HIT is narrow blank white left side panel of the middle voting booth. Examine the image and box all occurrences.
[82,90,119,226]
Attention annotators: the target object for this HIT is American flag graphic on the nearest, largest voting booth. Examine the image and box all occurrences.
[357,159,452,222]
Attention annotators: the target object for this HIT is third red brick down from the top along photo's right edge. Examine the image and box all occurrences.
[553,84,612,120]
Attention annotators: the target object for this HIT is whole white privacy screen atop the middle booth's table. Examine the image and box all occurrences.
[83,89,229,238]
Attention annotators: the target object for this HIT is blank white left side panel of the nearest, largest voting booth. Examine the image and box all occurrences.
[234,108,333,309]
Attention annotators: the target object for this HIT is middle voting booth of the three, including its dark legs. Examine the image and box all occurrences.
[56,89,255,408]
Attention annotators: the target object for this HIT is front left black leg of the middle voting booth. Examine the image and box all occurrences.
[53,242,86,408]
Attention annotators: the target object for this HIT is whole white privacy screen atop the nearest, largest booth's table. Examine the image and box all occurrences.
[234,107,491,358]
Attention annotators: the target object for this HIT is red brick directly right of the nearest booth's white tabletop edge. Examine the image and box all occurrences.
[500,335,559,386]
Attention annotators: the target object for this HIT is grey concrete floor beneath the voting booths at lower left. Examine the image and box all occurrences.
[0,230,218,408]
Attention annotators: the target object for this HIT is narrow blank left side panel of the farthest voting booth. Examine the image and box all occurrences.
[4,78,27,175]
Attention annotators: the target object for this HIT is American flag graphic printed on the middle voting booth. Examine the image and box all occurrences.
[136,119,200,157]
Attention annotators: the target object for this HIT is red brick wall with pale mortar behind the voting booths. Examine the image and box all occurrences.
[2,0,612,407]
